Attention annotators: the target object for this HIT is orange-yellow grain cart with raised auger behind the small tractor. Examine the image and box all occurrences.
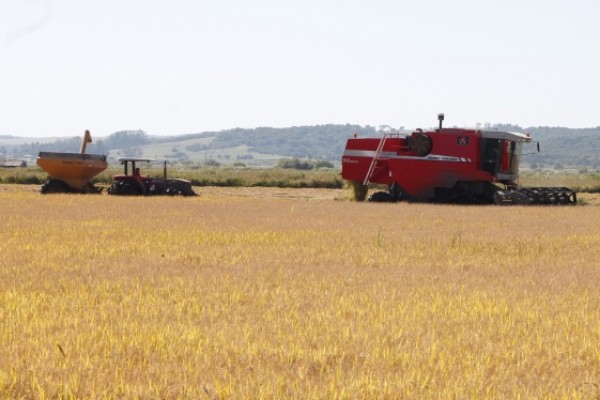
[36,131,108,194]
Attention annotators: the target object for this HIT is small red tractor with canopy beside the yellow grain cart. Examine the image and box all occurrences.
[108,157,196,196]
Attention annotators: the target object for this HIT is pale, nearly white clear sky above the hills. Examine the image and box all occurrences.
[0,0,600,137]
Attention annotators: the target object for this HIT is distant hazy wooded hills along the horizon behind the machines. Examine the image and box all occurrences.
[0,124,600,168]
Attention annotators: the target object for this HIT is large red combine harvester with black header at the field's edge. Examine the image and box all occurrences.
[342,114,577,204]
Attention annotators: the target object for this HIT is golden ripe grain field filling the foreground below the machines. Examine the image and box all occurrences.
[0,186,600,399]
